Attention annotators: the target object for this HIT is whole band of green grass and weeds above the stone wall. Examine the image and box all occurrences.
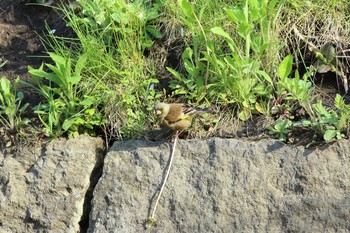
[2,0,350,144]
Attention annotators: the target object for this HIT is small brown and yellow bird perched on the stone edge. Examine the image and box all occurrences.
[154,103,208,131]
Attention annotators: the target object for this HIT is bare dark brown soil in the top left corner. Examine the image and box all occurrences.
[0,0,66,104]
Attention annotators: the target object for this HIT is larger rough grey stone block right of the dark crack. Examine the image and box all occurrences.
[88,138,350,233]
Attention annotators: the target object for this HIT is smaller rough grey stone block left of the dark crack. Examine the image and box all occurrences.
[0,136,104,233]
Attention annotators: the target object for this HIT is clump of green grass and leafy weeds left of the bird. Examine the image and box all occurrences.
[25,0,162,138]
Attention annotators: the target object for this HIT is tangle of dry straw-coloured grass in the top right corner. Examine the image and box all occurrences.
[279,0,350,92]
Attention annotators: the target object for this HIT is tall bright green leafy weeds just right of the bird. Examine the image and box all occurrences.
[163,0,284,120]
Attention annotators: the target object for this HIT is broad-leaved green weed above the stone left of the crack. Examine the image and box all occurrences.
[27,53,105,138]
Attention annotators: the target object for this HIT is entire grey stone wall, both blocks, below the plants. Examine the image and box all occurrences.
[0,137,350,233]
